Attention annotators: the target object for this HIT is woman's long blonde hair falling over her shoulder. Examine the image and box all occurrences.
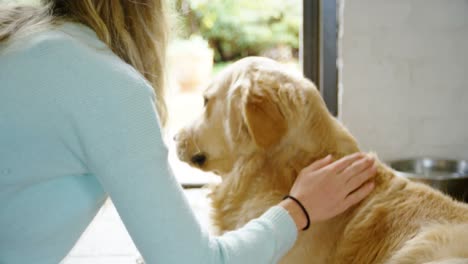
[0,0,169,126]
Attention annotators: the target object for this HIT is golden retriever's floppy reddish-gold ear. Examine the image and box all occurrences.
[243,80,287,148]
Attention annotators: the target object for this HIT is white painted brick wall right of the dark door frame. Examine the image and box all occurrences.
[339,0,468,160]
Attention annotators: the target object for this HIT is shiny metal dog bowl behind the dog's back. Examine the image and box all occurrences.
[389,158,468,202]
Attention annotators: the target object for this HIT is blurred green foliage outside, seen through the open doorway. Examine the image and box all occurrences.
[176,0,302,62]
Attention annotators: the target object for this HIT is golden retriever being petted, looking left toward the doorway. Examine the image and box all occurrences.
[175,57,468,264]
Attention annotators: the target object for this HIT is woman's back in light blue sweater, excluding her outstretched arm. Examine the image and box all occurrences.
[0,23,154,263]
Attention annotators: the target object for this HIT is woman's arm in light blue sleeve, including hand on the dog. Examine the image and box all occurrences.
[71,75,374,264]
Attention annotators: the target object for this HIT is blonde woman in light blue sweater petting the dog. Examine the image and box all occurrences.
[0,0,375,264]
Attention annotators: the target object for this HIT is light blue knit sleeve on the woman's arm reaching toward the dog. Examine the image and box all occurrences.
[52,27,297,264]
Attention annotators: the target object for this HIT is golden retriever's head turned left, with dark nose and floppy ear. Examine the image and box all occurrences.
[175,57,356,175]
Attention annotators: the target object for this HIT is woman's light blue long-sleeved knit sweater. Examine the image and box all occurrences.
[0,23,297,264]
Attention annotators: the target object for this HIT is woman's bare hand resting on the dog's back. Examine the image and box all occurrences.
[280,153,377,230]
